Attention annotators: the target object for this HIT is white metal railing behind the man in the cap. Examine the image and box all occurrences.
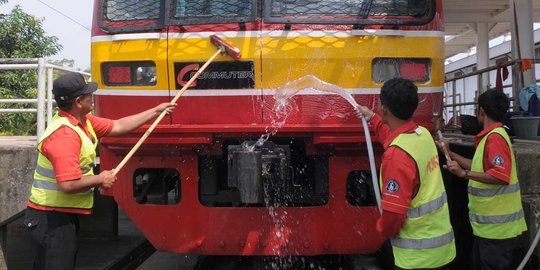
[0,58,90,140]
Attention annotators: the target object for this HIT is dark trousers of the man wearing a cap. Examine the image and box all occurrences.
[24,208,79,270]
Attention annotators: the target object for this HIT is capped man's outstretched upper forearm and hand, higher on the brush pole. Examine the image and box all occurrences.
[108,103,176,136]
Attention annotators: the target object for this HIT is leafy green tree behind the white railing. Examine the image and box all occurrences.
[0,5,62,135]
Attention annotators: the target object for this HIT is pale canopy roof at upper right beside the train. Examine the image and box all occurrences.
[443,0,540,58]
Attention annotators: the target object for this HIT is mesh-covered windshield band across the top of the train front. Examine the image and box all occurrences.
[97,0,435,33]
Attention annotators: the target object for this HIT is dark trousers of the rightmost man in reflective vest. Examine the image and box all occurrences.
[471,236,524,270]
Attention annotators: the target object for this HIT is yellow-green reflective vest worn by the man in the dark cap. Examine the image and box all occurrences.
[29,114,97,209]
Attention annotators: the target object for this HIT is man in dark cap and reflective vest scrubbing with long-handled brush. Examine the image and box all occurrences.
[24,73,175,269]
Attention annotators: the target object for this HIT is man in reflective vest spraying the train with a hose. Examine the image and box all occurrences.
[358,78,456,269]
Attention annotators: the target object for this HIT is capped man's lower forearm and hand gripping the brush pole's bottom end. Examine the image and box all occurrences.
[58,170,116,193]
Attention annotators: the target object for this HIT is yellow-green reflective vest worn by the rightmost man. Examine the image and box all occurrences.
[468,127,527,239]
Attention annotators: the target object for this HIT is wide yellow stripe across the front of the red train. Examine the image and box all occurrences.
[92,34,444,90]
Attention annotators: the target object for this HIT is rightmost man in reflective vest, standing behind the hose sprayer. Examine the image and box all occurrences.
[438,90,527,269]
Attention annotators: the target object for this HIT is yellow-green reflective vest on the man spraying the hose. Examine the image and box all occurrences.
[380,126,456,269]
